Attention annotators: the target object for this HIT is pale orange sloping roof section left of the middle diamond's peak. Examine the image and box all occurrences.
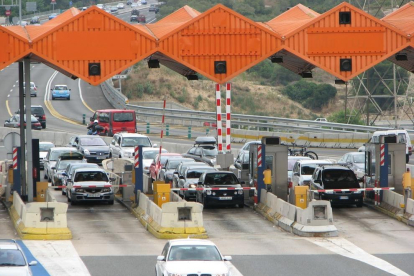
[146,6,200,39]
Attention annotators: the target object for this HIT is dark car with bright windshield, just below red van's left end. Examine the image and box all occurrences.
[69,135,109,163]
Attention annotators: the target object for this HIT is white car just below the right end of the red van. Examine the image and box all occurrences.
[109,132,157,158]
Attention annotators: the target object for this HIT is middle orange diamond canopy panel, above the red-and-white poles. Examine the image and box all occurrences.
[159,4,282,83]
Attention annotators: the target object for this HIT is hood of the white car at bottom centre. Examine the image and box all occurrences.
[165,261,229,275]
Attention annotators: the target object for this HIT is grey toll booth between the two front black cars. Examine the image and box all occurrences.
[249,137,288,201]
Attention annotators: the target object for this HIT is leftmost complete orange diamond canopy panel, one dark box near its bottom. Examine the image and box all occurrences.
[32,6,156,85]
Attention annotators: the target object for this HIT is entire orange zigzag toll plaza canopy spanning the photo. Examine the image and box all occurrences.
[0,2,414,85]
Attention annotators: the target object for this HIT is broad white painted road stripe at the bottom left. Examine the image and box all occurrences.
[24,240,91,276]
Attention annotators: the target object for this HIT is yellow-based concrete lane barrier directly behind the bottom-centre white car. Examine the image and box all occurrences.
[133,193,208,239]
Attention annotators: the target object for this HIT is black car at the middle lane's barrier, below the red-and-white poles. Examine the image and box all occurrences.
[196,171,244,208]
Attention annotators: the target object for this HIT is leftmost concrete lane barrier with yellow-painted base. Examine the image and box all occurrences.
[8,190,72,240]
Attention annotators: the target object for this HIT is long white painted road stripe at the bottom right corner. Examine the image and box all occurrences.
[307,238,409,276]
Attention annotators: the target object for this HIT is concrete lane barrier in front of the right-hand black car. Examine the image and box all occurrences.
[255,189,338,237]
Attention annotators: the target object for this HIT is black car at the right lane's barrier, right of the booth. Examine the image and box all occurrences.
[310,165,364,207]
